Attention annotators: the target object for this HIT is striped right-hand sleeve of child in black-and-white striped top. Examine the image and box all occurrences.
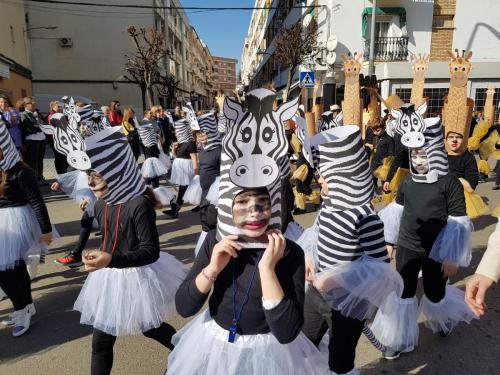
[356,214,389,260]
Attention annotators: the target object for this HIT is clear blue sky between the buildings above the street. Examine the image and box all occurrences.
[181,0,255,69]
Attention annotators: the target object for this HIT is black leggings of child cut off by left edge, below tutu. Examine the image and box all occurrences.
[0,260,33,311]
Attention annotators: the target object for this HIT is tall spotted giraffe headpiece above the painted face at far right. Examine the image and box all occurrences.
[442,49,474,152]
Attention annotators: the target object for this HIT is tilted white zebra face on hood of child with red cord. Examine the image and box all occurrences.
[40,113,90,171]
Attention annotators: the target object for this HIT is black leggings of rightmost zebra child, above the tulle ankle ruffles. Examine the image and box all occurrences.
[396,247,447,303]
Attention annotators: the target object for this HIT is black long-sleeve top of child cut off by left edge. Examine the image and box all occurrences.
[0,163,52,234]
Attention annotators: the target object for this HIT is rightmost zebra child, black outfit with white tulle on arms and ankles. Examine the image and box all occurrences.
[372,111,475,359]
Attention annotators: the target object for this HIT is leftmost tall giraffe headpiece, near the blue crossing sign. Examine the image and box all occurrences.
[342,53,363,126]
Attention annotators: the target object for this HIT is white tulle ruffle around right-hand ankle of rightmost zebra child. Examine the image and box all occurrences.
[418,285,478,333]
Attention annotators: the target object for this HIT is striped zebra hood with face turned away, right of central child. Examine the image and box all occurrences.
[311,125,374,211]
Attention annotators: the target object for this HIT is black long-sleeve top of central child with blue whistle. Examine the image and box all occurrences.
[175,230,305,344]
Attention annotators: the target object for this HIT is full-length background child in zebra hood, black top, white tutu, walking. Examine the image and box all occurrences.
[165,118,199,218]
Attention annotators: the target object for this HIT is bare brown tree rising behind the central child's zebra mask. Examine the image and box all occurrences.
[274,18,319,101]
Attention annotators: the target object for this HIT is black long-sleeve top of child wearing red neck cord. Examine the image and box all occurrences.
[94,195,160,268]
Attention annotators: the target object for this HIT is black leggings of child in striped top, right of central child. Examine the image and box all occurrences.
[302,286,364,374]
